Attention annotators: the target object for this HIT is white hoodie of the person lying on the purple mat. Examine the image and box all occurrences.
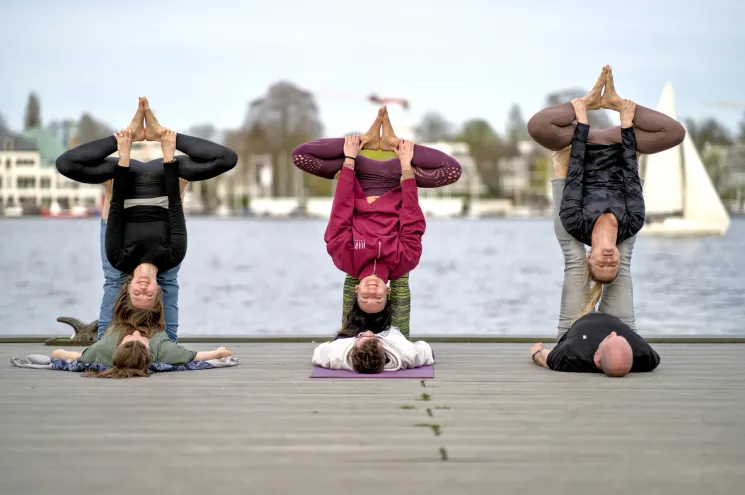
[312,327,435,371]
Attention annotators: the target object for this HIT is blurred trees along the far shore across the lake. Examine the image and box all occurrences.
[7,86,745,203]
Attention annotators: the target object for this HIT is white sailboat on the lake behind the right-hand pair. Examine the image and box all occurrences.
[641,83,730,237]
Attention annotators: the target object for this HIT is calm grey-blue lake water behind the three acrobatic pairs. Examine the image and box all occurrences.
[0,218,745,335]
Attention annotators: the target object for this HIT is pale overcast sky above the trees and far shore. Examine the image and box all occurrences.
[0,0,745,140]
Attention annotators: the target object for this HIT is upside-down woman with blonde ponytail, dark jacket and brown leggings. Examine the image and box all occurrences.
[528,66,685,316]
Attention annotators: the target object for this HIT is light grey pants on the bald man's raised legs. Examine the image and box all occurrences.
[551,178,636,337]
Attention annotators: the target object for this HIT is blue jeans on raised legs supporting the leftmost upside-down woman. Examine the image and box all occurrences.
[98,219,181,342]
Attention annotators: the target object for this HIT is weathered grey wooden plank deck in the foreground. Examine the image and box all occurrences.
[0,344,745,495]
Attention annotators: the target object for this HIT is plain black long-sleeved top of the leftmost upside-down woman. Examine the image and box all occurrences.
[106,162,187,273]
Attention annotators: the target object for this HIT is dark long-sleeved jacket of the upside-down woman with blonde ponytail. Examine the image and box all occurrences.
[559,123,645,246]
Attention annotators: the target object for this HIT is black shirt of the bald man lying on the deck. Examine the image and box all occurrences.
[546,312,660,373]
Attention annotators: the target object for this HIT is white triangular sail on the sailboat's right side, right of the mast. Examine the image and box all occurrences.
[682,131,730,234]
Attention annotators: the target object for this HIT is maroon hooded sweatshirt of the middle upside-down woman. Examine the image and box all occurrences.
[323,167,427,283]
